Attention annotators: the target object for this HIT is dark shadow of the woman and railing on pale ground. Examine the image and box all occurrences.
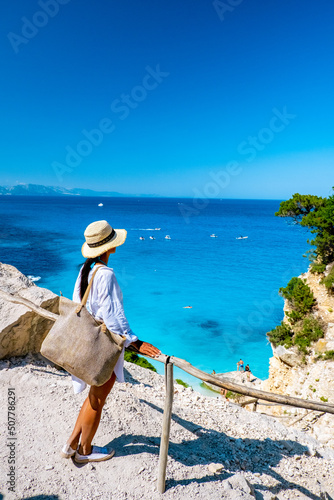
[107,399,319,500]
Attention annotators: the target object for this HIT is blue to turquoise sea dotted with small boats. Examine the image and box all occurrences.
[0,196,308,384]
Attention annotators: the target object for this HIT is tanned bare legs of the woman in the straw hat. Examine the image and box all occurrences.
[68,373,116,455]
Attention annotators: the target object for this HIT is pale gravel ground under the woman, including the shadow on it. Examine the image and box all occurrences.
[0,355,334,500]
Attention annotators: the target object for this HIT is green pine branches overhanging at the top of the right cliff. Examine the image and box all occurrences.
[275,188,334,266]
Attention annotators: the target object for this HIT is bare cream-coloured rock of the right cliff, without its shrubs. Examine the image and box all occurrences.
[260,268,334,447]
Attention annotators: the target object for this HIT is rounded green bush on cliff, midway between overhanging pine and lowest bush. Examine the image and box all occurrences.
[279,277,316,325]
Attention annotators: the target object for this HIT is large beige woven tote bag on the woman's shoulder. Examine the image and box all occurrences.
[41,266,125,385]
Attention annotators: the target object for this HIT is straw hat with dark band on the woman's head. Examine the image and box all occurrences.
[81,220,127,259]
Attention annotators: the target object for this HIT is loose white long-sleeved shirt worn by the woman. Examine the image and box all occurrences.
[72,265,138,394]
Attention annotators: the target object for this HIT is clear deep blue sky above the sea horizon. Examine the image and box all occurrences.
[0,0,334,199]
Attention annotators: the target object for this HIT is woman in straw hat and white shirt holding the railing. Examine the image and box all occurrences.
[61,220,160,463]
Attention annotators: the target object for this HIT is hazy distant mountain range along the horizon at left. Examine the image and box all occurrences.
[0,184,156,197]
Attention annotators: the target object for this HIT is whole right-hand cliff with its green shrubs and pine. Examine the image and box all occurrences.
[262,193,334,446]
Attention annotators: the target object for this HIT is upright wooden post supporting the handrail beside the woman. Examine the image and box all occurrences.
[158,356,174,493]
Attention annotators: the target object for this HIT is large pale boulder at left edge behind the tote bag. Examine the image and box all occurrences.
[0,263,59,359]
